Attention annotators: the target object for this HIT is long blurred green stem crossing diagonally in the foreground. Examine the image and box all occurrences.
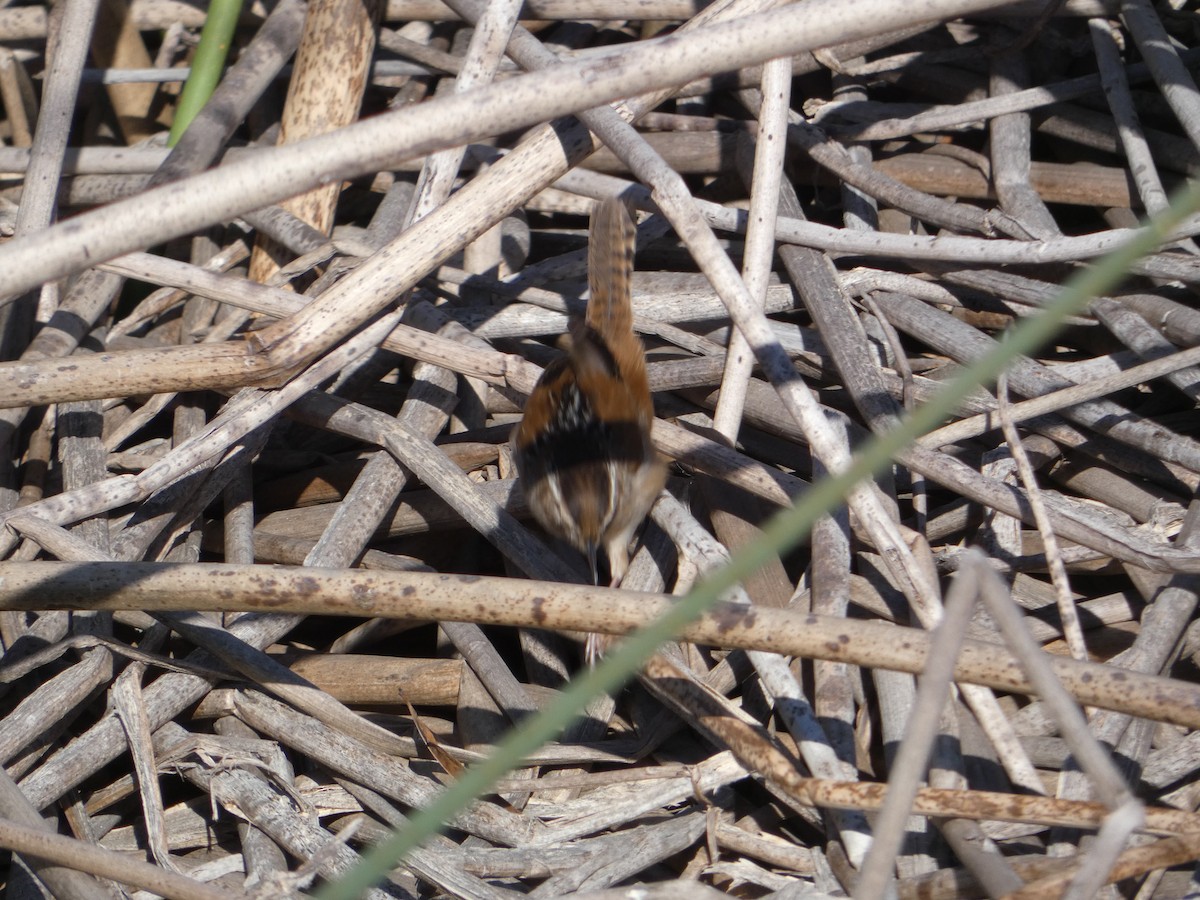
[318,176,1200,900]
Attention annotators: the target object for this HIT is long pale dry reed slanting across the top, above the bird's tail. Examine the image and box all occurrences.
[0,0,1022,295]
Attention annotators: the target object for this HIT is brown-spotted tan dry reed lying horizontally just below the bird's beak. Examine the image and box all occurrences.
[0,563,1200,727]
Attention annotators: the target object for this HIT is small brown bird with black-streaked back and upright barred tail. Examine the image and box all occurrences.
[511,198,666,586]
